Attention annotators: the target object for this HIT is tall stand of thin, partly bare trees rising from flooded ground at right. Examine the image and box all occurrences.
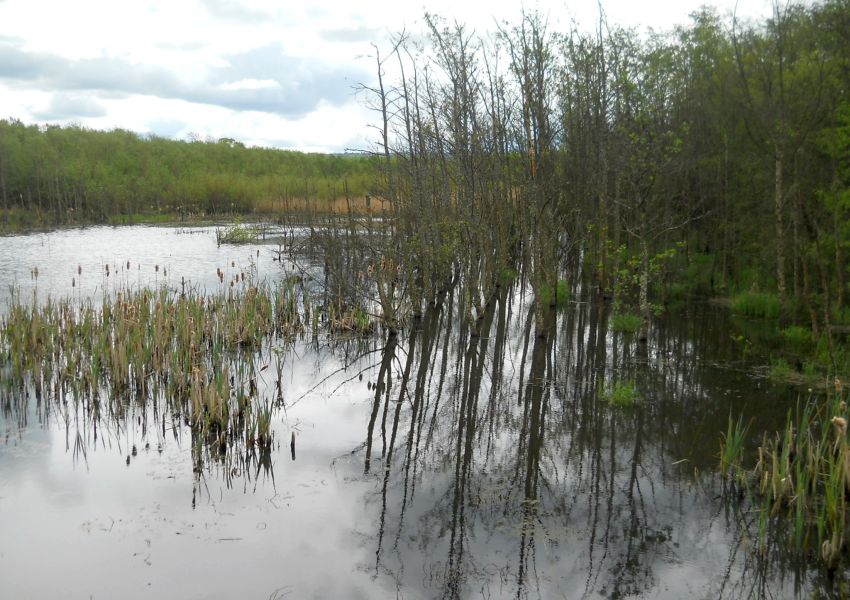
[354,0,850,348]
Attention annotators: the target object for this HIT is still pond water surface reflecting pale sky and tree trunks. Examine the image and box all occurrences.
[0,227,838,598]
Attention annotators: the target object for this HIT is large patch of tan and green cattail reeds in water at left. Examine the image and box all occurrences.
[0,279,309,448]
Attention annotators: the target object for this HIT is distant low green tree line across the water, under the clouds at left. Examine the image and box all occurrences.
[0,119,373,223]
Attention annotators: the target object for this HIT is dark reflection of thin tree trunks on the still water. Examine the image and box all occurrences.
[364,288,820,598]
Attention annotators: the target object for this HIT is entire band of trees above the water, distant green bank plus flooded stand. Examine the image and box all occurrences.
[0,0,850,354]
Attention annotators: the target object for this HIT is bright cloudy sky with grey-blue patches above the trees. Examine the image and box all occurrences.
[0,0,770,152]
